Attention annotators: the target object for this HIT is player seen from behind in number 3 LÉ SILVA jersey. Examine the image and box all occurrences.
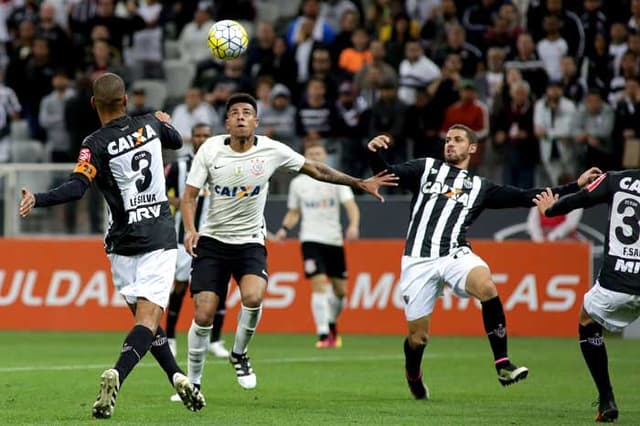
[20,73,205,419]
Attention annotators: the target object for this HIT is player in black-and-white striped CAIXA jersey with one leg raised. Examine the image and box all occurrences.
[368,124,600,399]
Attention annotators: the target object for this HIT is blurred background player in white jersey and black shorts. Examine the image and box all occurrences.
[276,143,360,349]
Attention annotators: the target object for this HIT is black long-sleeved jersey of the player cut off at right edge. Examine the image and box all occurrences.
[545,169,640,295]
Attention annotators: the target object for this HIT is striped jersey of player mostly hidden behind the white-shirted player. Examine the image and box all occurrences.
[166,155,209,244]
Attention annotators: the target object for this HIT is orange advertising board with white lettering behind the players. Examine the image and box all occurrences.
[0,239,591,336]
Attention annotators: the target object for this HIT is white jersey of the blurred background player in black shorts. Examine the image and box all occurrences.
[287,175,353,246]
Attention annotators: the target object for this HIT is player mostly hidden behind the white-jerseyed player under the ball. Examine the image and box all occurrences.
[166,123,229,360]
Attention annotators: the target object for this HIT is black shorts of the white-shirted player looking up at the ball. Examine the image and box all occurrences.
[191,237,268,299]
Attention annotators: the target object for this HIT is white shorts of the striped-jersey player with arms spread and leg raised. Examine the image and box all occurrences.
[398,247,489,321]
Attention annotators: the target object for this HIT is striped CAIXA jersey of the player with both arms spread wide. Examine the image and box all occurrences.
[371,155,578,258]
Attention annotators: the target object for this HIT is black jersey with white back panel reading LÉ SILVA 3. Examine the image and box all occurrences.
[71,114,182,256]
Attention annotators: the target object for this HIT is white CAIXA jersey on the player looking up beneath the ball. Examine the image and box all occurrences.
[187,135,305,244]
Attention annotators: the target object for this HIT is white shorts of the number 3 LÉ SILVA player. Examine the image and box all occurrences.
[109,249,177,309]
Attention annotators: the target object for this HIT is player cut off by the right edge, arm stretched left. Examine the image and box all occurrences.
[534,169,640,422]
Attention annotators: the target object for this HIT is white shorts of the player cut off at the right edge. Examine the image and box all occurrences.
[583,281,640,332]
